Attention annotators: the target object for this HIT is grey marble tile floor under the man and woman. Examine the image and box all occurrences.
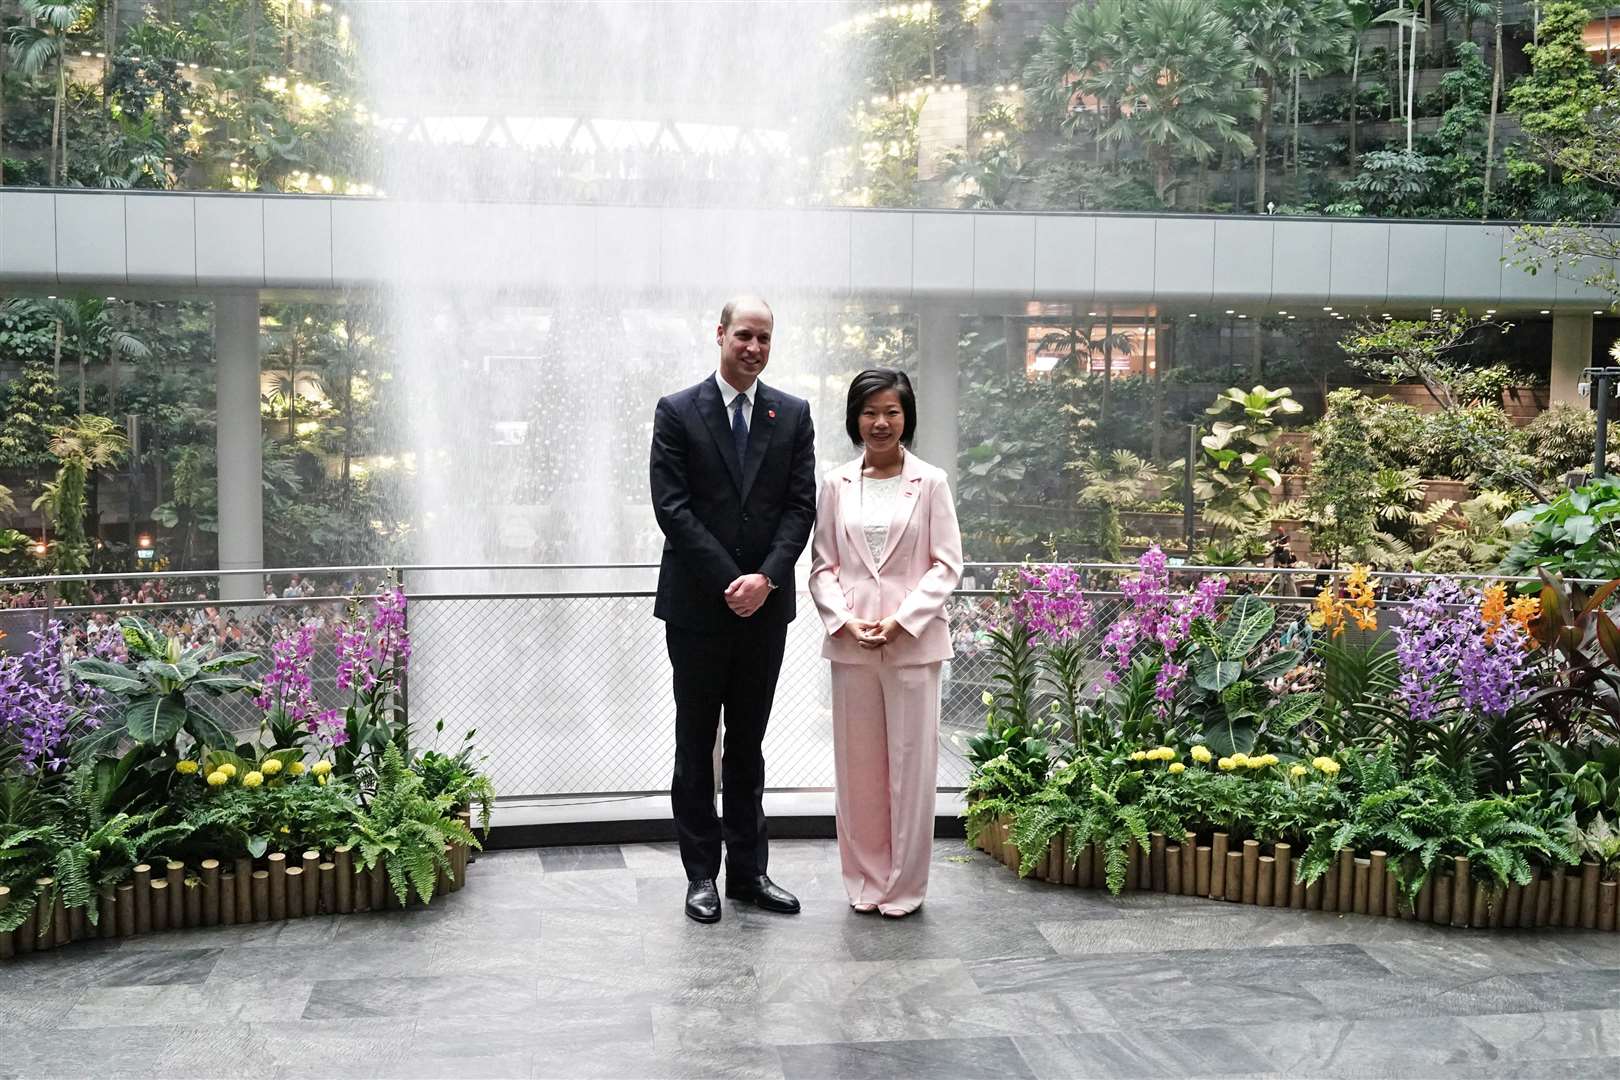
[0,840,1620,1080]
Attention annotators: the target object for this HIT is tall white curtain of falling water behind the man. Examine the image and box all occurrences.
[345,0,857,793]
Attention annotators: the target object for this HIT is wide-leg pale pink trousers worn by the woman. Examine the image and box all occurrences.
[833,662,940,915]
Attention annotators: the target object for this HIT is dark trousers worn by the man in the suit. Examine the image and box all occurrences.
[664,623,787,881]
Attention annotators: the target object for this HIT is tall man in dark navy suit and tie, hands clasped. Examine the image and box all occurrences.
[651,296,816,923]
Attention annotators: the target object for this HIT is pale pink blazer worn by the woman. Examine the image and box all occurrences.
[810,453,962,665]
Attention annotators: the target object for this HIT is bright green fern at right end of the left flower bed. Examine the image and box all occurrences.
[350,743,481,905]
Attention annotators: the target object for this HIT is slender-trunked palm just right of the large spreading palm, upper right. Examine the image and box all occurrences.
[1220,0,1351,210]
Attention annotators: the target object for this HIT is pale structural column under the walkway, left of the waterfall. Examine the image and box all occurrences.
[214,291,264,601]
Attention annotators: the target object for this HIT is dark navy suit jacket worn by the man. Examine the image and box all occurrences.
[651,376,816,633]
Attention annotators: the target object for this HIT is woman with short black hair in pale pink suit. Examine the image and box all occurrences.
[810,369,962,916]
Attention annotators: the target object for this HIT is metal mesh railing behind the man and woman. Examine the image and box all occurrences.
[0,567,1464,797]
